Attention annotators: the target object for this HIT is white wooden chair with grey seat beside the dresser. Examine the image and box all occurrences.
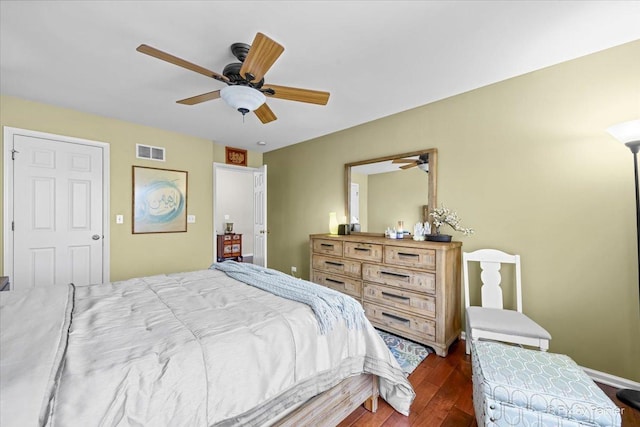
[462,249,551,354]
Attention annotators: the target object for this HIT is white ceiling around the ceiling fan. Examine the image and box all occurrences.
[0,0,640,152]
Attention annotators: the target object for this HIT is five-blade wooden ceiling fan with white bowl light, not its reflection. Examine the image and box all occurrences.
[136,33,329,123]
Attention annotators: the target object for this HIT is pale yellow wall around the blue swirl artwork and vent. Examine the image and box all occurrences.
[0,96,262,281]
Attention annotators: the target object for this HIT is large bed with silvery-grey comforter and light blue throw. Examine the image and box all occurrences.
[0,261,415,427]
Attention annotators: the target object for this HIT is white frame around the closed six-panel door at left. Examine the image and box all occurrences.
[2,126,111,289]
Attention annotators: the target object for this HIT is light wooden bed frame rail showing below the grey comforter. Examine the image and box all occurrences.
[274,374,379,427]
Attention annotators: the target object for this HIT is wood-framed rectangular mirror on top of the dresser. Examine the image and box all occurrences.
[345,148,438,233]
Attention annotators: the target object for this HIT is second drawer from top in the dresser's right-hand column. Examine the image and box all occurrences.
[362,263,436,294]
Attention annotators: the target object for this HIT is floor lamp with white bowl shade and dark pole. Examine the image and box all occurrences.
[607,120,640,411]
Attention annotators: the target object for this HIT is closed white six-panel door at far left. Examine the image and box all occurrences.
[5,132,108,289]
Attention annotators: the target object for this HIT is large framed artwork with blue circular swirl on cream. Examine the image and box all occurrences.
[131,166,188,234]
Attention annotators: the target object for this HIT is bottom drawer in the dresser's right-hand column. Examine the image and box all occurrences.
[364,301,436,341]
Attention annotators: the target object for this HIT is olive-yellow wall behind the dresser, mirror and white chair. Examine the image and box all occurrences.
[264,41,640,381]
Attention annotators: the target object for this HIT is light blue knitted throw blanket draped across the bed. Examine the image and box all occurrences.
[209,261,365,335]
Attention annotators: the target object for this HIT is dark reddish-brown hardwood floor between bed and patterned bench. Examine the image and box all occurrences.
[340,341,640,427]
